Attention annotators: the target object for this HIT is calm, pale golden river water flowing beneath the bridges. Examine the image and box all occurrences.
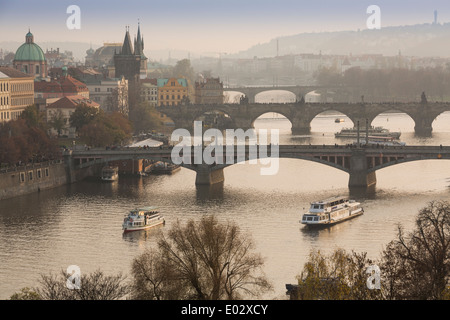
[0,96,450,299]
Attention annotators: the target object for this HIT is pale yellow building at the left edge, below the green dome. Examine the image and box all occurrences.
[0,67,34,120]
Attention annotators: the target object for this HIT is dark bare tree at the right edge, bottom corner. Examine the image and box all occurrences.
[380,201,450,300]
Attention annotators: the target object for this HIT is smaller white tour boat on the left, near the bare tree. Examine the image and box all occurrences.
[122,206,165,232]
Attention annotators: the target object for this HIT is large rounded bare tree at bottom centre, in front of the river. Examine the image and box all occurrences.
[132,216,271,300]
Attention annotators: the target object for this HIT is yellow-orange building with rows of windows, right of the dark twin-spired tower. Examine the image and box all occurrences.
[157,78,192,106]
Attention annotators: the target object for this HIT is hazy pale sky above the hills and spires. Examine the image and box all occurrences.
[0,0,450,53]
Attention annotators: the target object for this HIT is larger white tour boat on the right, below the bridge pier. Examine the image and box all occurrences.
[301,197,364,227]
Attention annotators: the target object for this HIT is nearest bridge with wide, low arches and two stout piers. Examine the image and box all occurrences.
[64,145,450,187]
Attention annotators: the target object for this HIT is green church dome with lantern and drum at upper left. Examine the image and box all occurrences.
[13,31,48,78]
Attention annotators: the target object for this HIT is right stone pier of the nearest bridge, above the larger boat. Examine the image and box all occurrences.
[348,149,377,188]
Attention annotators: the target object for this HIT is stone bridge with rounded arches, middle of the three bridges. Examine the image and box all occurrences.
[157,102,450,136]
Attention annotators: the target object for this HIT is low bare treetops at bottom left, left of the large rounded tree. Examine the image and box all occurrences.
[35,270,129,300]
